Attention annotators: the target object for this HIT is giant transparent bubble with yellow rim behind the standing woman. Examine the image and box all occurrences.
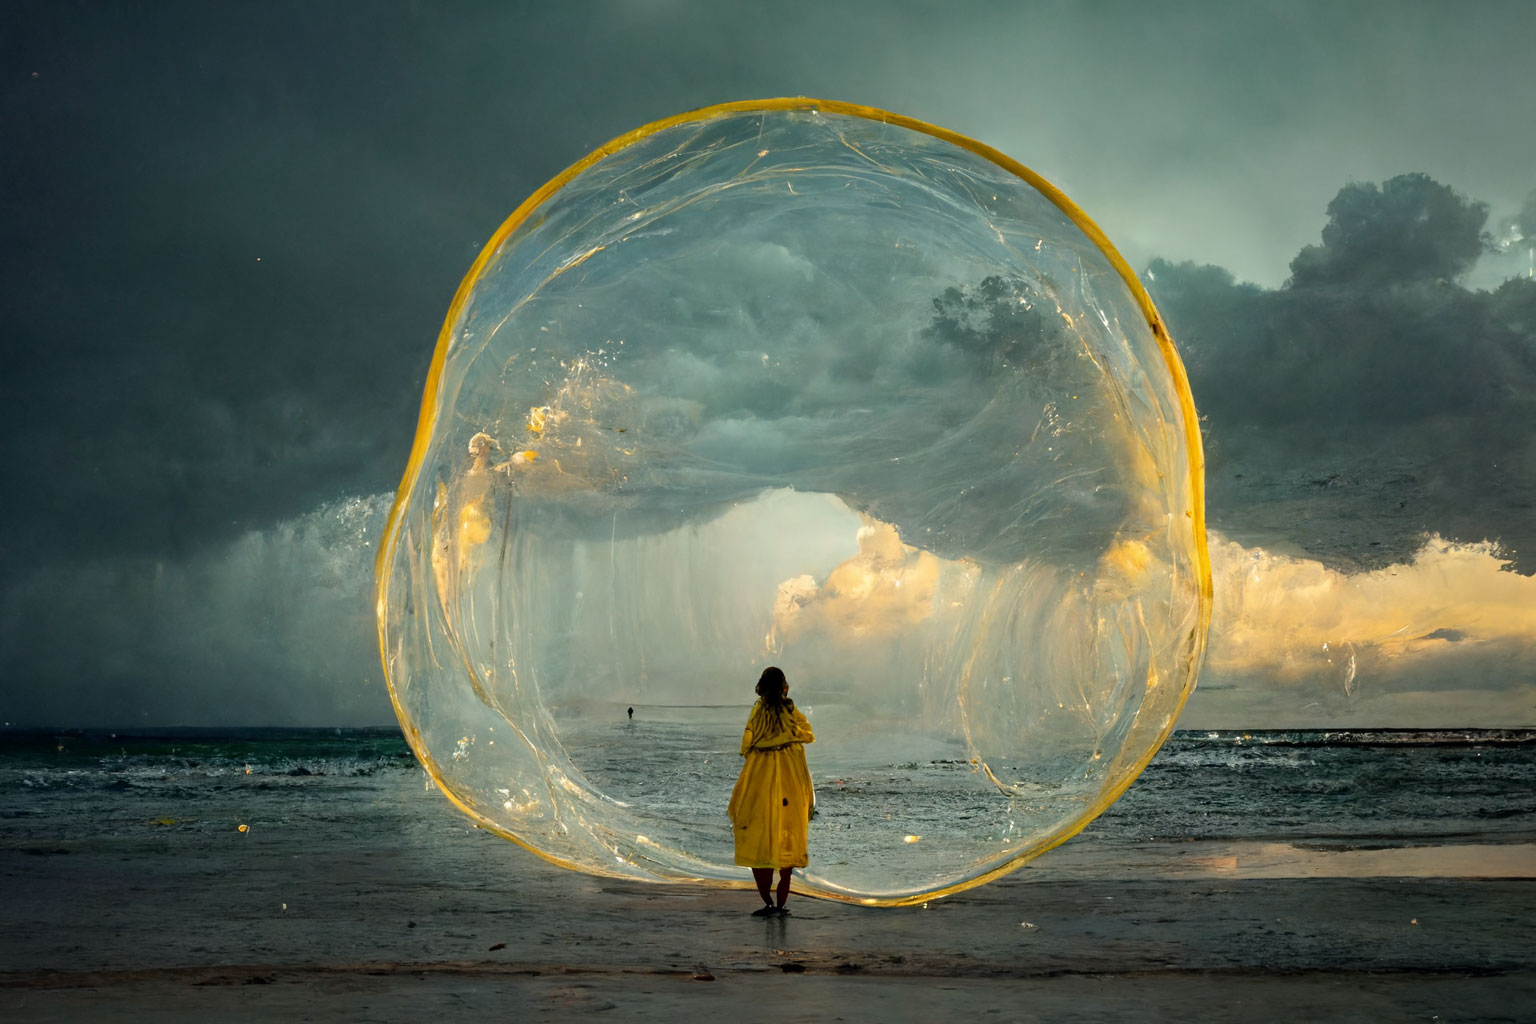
[378,100,1210,904]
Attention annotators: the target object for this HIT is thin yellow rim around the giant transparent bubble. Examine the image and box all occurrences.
[373,97,1212,907]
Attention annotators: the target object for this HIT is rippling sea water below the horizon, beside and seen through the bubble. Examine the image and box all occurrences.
[0,721,1536,867]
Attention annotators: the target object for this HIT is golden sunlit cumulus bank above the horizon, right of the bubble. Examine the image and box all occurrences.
[1183,533,1536,728]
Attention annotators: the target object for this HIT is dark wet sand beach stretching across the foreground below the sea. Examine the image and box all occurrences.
[0,772,1536,1021]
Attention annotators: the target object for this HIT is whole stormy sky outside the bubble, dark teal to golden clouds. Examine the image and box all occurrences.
[0,0,1536,728]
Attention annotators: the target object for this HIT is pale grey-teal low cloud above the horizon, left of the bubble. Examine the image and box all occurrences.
[0,493,392,726]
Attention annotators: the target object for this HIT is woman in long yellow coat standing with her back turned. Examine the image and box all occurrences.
[730,666,816,917]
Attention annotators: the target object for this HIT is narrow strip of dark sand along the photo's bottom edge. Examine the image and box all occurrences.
[12,970,1536,1024]
